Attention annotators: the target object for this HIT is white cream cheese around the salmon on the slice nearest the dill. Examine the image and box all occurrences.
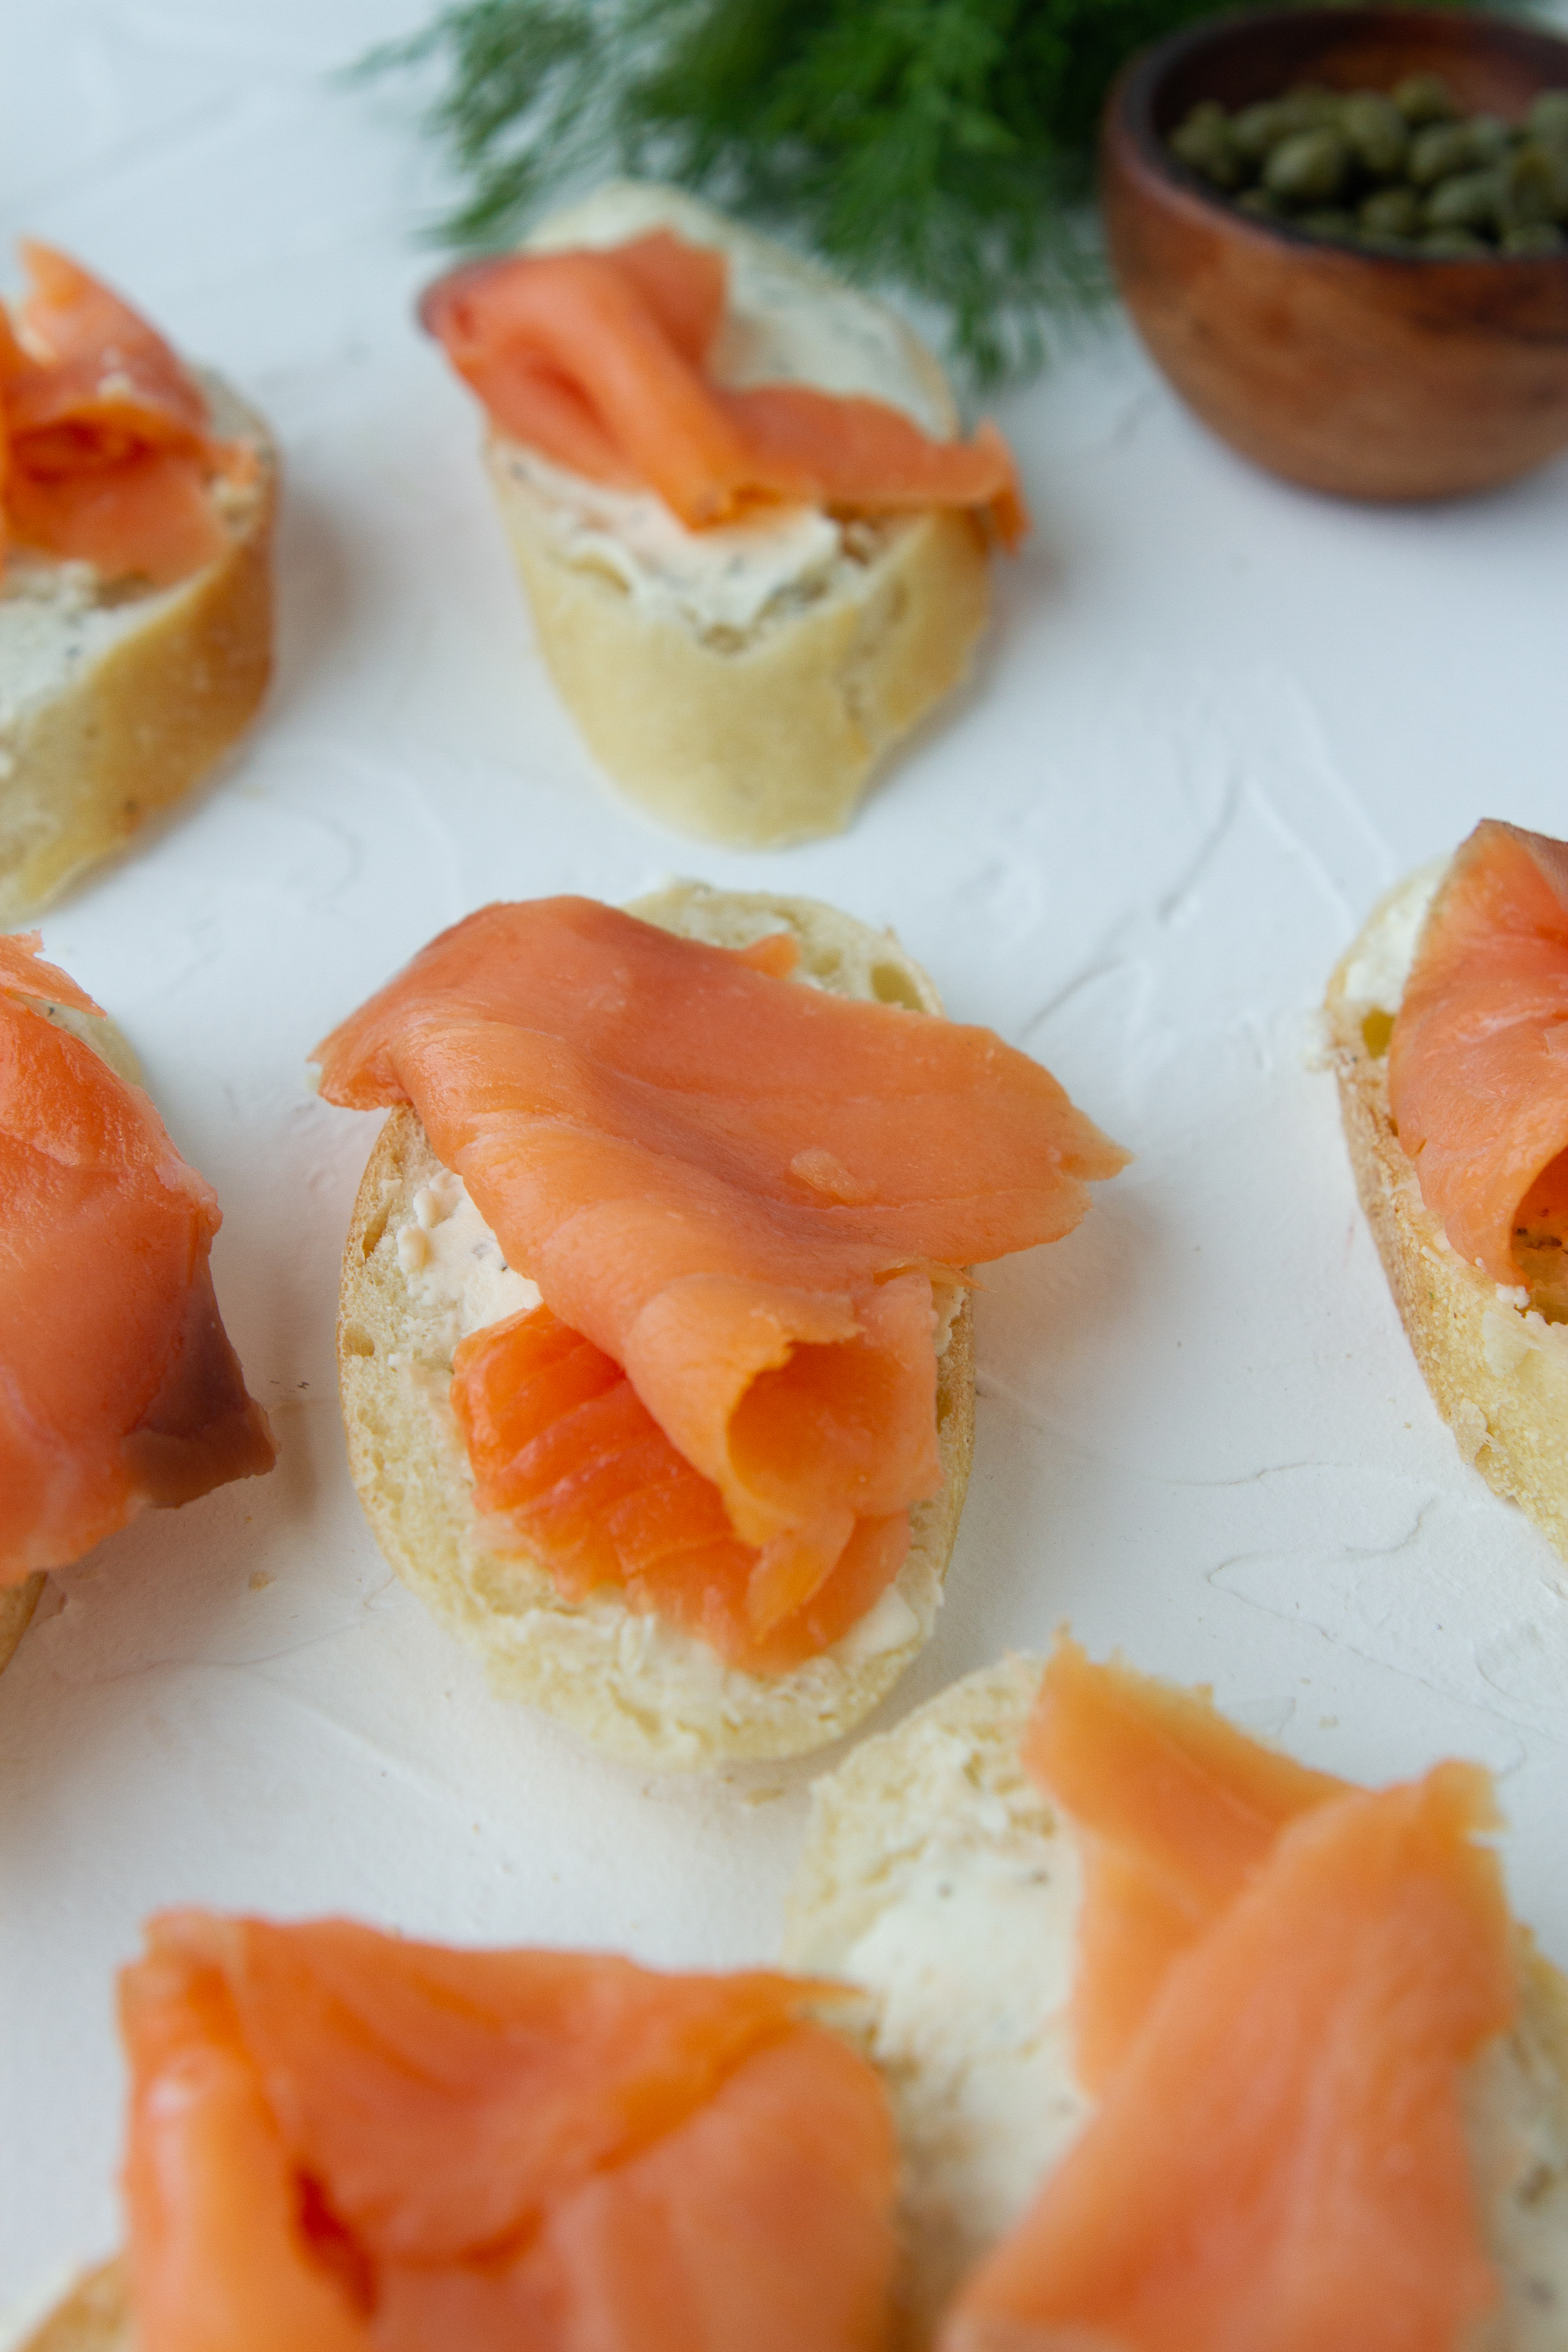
[496,181,955,644]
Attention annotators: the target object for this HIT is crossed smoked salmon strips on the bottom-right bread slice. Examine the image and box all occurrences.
[941,1651,1516,2352]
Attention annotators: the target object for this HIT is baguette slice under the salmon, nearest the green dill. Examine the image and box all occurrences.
[484,183,990,849]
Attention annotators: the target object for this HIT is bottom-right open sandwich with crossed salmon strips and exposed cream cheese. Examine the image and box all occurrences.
[785,1642,1568,2352]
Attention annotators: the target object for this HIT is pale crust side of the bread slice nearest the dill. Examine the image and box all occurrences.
[484,456,990,849]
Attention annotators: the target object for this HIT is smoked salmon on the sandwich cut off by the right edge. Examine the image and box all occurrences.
[1389,818,1568,1319]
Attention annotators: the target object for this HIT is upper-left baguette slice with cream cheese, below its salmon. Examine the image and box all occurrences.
[0,376,277,926]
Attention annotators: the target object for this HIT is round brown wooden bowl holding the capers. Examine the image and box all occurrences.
[1102,7,1568,499]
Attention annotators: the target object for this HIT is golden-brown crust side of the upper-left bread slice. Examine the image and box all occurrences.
[0,381,277,924]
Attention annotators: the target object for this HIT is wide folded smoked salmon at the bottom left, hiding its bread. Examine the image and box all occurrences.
[120,1912,896,2352]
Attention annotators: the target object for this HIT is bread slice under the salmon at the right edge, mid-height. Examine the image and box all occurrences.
[1323,861,1568,1559]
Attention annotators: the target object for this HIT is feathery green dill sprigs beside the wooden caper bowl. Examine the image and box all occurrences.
[355,0,1250,383]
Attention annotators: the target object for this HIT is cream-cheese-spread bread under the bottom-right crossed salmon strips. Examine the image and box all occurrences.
[783,1658,1568,2352]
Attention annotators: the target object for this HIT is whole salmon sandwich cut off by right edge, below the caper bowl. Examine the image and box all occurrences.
[1328,818,1568,1557]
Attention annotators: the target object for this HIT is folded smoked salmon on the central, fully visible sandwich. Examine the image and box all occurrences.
[315,898,1126,1656]
